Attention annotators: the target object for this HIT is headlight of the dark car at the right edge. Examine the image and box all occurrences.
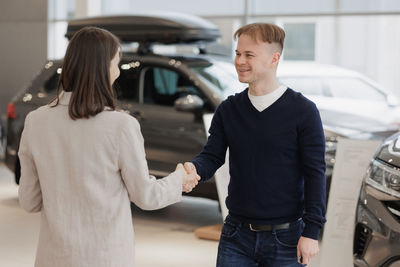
[365,160,400,198]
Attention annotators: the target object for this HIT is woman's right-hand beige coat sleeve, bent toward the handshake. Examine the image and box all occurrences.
[118,116,183,210]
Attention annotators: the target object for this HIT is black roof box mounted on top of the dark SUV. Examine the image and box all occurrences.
[65,13,221,44]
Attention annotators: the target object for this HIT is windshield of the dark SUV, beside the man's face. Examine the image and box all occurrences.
[191,62,247,98]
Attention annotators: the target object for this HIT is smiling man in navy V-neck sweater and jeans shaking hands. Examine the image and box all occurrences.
[185,23,326,267]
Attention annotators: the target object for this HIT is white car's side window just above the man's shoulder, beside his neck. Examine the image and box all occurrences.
[279,77,324,96]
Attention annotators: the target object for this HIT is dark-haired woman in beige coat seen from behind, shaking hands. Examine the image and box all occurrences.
[18,27,198,267]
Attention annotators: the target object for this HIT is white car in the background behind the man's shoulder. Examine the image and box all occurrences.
[278,62,400,127]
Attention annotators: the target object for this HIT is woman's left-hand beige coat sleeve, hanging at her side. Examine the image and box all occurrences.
[18,114,42,212]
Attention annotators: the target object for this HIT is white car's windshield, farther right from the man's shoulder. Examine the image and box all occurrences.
[327,77,386,101]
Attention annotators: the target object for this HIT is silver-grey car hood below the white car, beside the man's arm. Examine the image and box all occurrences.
[319,108,398,139]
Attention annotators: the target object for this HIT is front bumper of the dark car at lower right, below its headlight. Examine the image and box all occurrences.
[353,184,400,267]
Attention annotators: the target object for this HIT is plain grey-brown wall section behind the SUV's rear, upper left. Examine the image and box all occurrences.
[0,0,47,116]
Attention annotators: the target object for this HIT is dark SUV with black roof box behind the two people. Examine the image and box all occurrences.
[5,15,244,199]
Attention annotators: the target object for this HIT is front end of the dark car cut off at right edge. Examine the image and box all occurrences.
[353,133,400,267]
